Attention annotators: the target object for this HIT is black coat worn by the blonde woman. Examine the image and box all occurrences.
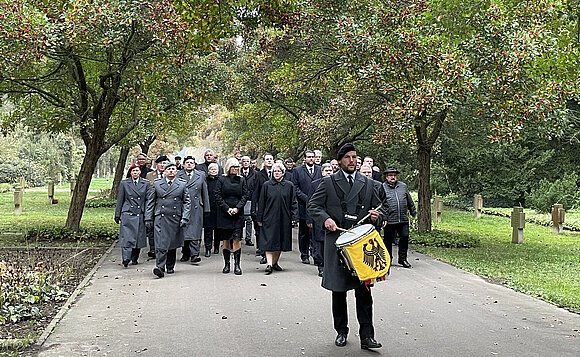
[215,175,248,229]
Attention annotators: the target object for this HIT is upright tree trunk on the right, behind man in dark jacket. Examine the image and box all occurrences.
[417,145,431,233]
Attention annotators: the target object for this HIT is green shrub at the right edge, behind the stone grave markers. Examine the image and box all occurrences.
[527,173,580,213]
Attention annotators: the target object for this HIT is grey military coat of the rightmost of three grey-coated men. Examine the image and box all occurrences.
[175,170,210,240]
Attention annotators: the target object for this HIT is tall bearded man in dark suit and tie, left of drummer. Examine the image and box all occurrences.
[292,150,322,264]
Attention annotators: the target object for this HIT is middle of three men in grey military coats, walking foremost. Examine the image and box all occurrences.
[145,162,191,278]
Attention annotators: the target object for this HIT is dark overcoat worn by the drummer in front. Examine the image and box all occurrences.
[307,170,386,291]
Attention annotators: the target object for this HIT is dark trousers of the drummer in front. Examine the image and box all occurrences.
[332,285,375,340]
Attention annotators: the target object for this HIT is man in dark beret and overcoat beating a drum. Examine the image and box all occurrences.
[307,143,385,349]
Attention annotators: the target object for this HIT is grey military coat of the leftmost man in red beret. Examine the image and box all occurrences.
[115,177,149,248]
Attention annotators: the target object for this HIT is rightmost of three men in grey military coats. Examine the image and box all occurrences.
[176,156,211,263]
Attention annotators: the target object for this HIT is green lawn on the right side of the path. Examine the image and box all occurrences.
[413,207,580,312]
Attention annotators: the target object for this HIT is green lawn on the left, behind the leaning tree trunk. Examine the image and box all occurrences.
[0,178,118,246]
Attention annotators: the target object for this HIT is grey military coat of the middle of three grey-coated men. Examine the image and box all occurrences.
[145,178,191,250]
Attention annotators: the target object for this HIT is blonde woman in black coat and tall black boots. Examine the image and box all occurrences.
[215,158,248,275]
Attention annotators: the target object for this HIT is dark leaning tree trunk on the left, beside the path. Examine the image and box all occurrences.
[66,145,102,231]
